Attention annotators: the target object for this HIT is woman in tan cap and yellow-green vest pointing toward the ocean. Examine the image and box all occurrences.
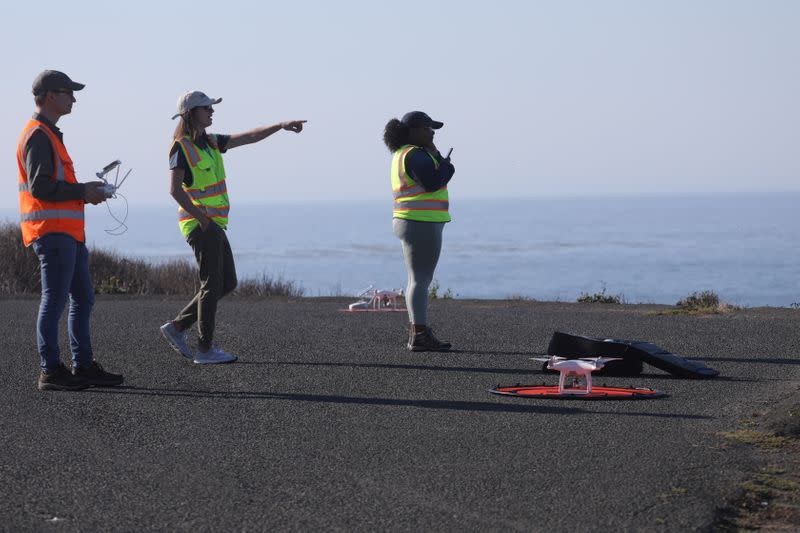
[161,91,306,364]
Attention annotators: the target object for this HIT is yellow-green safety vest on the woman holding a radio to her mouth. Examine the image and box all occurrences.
[391,144,451,222]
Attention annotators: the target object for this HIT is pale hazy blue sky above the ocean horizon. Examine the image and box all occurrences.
[0,0,800,208]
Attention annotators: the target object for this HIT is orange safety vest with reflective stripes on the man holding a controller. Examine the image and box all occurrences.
[17,119,86,246]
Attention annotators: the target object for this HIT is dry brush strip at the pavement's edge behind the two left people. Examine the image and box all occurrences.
[0,223,303,297]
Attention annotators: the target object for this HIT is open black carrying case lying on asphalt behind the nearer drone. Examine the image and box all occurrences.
[544,331,719,379]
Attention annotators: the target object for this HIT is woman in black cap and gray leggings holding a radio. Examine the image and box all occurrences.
[383,111,455,352]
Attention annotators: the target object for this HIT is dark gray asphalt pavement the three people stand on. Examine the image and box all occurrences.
[0,296,800,532]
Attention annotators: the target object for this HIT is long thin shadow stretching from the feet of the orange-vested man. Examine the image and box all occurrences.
[86,385,713,420]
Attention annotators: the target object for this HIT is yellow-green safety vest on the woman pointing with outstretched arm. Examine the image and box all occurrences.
[175,135,231,237]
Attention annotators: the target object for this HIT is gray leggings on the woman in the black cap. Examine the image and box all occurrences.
[392,218,444,325]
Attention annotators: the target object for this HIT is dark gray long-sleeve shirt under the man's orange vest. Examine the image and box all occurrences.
[23,113,86,202]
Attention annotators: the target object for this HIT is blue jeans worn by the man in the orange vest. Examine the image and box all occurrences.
[32,233,94,371]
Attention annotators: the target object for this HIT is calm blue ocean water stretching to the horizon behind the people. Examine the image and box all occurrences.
[0,193,800,306]
